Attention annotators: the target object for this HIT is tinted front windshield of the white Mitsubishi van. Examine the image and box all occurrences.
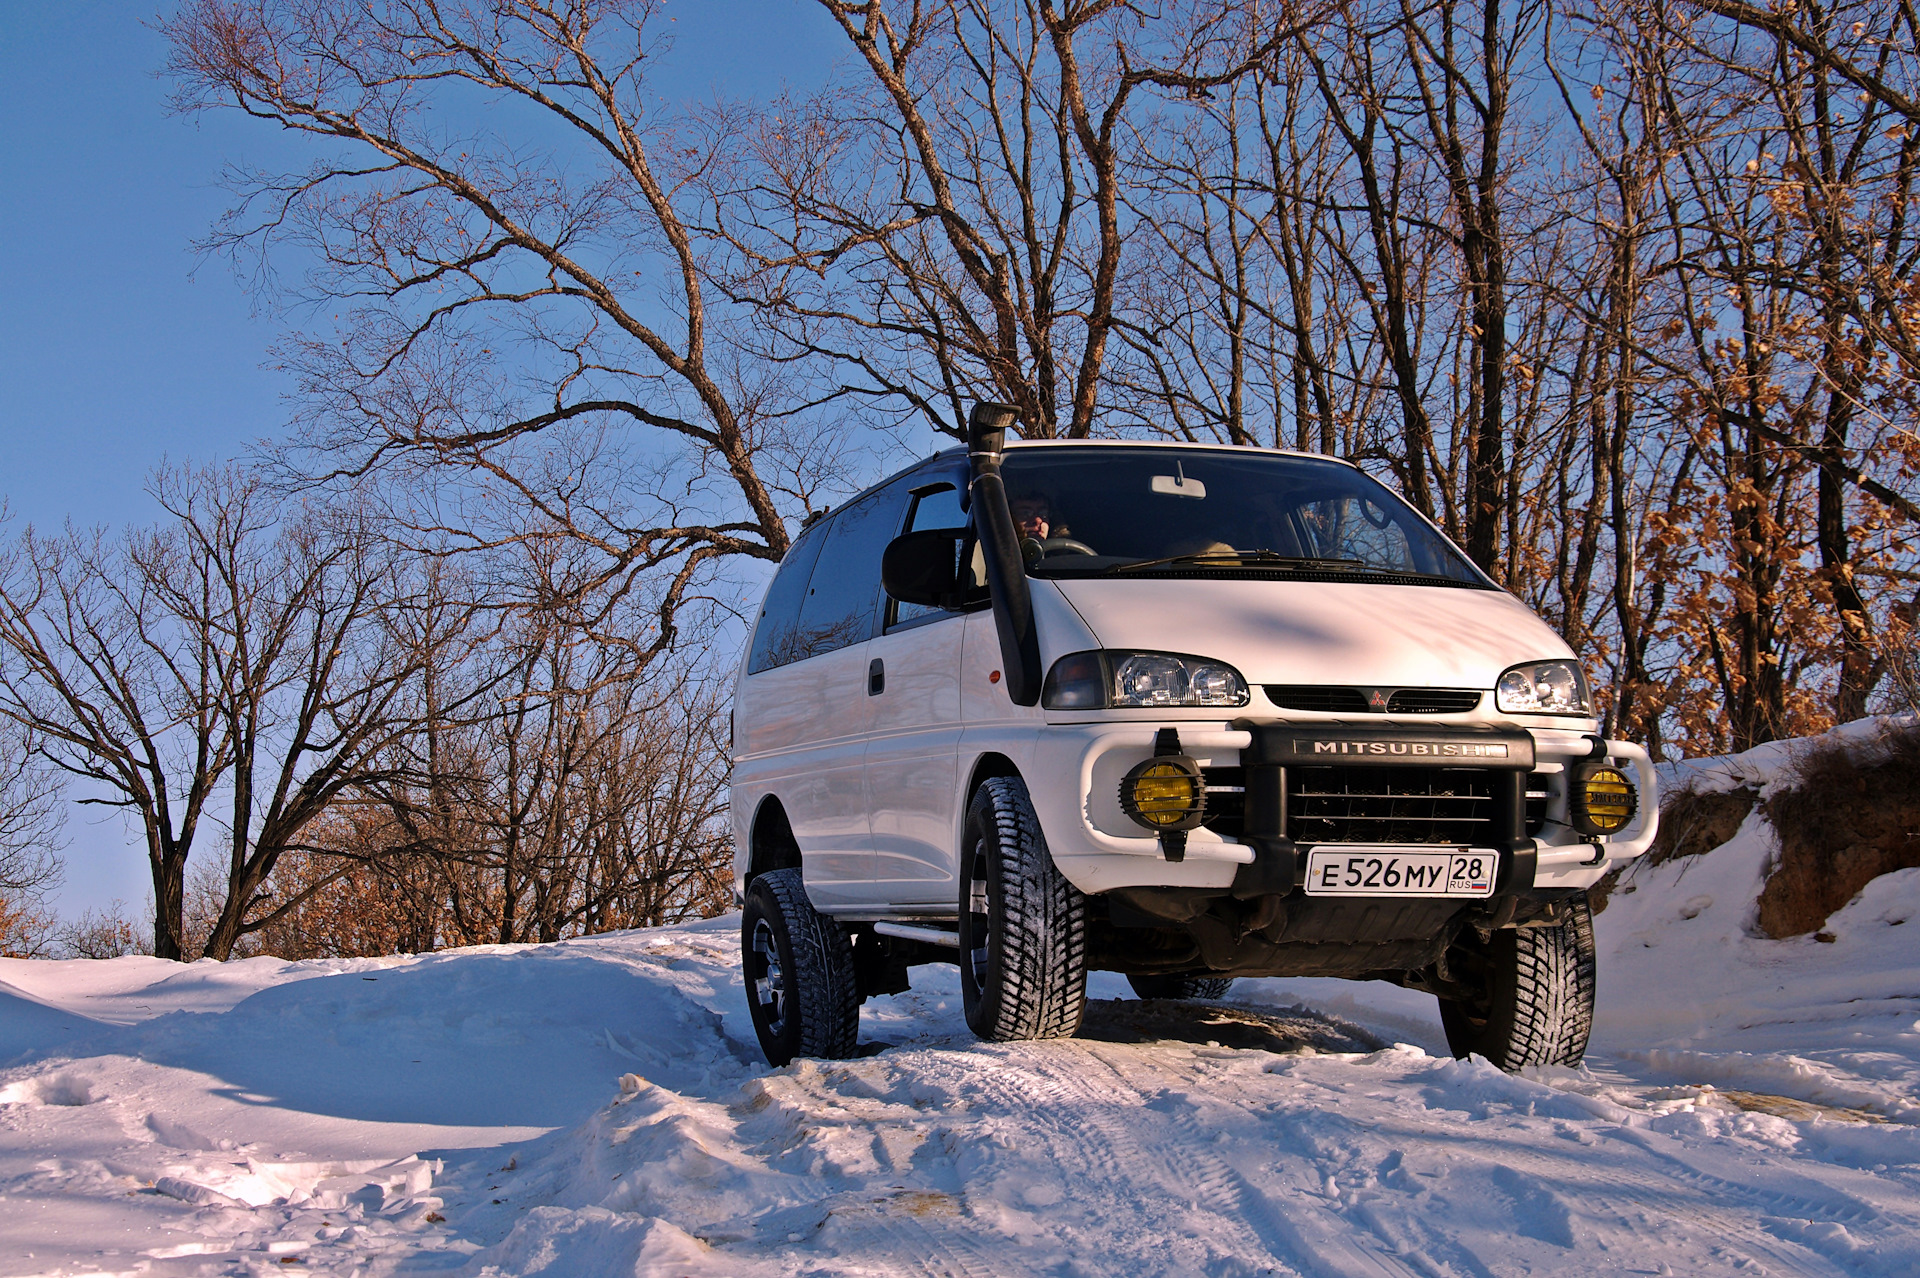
[1002,445,1486,587]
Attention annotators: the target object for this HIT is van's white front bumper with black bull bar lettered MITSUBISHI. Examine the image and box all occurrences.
[1035,722,1659,896]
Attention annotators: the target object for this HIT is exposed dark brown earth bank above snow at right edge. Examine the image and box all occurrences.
[1759,727,1920,938]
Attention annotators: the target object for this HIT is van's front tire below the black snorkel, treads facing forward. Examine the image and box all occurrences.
[960,777,1087,1042]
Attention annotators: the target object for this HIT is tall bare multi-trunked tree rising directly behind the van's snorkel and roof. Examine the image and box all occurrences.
[712,0,1308,438]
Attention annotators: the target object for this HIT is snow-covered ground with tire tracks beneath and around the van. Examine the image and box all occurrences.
[11,721,1920,1278]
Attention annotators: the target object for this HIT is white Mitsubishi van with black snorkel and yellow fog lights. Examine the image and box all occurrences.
[733,405,1657,1069]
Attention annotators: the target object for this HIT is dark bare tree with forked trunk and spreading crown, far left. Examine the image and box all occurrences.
[0,470,453,958]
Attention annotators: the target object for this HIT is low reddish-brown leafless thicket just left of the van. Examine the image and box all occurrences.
[257,635,732,958]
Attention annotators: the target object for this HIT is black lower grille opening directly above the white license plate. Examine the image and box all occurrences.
[1286,768,1496,846]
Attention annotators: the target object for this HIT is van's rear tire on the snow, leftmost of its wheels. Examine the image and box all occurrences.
[739,869,860,1065]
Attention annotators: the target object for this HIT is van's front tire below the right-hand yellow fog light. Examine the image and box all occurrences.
[1440,896,1596,1071]
